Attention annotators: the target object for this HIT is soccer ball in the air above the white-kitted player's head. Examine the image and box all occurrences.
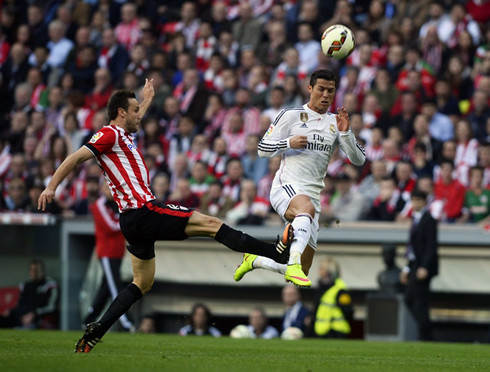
[322,25,356,59]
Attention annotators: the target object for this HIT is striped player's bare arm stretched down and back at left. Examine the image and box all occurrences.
[37,146,94,211]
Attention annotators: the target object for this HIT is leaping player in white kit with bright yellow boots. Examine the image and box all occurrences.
[235,69,365,287]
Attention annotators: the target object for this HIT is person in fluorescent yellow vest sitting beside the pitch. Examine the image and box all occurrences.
[313,257,354,339]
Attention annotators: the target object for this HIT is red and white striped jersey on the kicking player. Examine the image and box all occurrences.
[85,125,155,212]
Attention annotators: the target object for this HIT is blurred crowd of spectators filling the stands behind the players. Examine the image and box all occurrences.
[0,0,490,224]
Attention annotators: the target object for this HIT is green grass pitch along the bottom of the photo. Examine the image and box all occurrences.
[0,331,490,372]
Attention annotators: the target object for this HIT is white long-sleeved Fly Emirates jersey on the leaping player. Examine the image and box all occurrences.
[258,105,365,199]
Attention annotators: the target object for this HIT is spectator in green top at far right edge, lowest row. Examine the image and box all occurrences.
[456,166,490,223]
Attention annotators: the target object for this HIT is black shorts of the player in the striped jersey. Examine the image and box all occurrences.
[119,200,194,260]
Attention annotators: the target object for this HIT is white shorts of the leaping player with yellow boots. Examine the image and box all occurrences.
[270,184,321,250]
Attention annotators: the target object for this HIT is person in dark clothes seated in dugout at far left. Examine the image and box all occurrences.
[0,259,59,329]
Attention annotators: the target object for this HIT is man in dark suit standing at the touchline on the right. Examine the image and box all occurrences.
[400,190,439,341]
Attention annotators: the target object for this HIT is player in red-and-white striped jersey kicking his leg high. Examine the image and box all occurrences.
[38,79,293,353]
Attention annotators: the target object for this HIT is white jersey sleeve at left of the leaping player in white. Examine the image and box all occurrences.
[258,110,291,158]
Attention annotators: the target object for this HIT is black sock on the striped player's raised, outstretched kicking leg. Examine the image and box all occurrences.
[214,224,277,260]
